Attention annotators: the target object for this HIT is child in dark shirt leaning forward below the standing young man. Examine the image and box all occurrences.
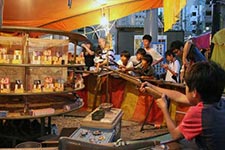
[134,54,154,79]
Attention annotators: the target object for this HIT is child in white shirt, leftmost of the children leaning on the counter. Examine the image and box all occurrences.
[117,50,133,71]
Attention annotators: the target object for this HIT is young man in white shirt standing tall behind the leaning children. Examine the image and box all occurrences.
[142,34,163,66]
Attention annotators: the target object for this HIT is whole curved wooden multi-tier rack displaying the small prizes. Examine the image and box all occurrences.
[0,26,87,143]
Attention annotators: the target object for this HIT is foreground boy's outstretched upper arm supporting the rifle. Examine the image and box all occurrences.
[140,82,191,105]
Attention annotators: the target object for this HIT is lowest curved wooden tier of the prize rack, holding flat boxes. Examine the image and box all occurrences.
[0,93,84,120]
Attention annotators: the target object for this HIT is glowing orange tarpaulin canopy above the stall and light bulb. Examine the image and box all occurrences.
[3,0,186,31]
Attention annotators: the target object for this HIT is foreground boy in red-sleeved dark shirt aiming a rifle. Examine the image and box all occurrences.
[140,62,225,150]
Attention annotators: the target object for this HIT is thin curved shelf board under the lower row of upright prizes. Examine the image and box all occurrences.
[0,85,85,96]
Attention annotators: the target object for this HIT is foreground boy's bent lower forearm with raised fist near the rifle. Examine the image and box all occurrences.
[156,95,183,139]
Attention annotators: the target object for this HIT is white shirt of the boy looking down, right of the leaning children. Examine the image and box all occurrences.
[165,60,180,82]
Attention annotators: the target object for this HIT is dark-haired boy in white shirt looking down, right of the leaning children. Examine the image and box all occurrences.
[162,50,180,82]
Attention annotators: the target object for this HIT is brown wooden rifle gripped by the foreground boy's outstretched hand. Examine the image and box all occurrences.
[104,67,162,99]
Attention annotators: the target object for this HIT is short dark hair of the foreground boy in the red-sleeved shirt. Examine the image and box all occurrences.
[185,62,225,104]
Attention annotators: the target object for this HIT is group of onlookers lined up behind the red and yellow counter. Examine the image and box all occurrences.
[81,34,206,83]
